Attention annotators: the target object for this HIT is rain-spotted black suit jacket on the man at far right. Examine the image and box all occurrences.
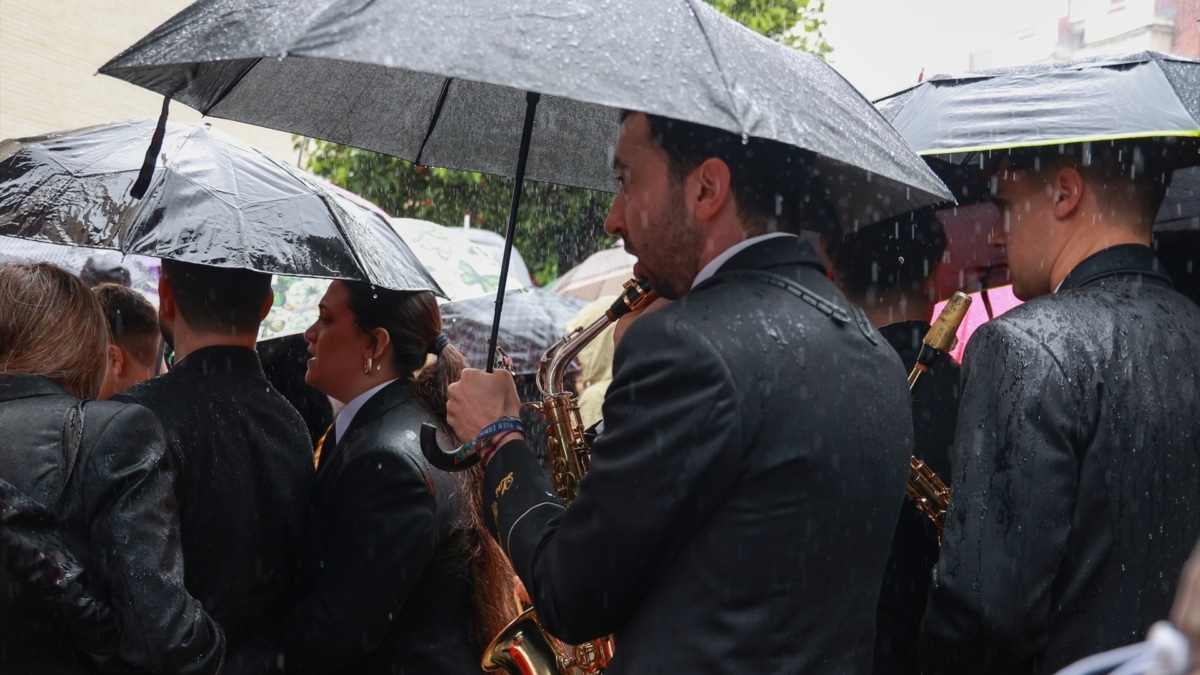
[922,245,1200,674]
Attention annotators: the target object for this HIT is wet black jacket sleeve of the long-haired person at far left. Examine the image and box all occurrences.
[81,402,224,674]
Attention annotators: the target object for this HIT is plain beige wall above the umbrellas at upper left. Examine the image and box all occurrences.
[0,0,296,163]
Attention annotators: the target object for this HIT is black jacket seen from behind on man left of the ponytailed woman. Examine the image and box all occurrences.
[115,347,314,651]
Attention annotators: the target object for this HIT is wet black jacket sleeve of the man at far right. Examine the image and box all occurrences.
[922,322,1079,674]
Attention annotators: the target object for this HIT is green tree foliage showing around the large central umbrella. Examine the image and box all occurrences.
[304,0,830,283]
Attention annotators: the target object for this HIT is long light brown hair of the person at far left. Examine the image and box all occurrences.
[0,263,110,399]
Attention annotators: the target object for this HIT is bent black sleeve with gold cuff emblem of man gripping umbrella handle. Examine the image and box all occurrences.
[484,312,744,643]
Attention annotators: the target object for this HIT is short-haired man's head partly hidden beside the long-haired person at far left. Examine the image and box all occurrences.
[92,282,162,399]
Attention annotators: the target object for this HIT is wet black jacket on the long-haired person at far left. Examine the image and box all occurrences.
[0,375,224,674]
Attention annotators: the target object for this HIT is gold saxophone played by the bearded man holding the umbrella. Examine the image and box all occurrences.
[480,279,658,675]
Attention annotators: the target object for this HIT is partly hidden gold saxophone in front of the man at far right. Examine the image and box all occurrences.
[905,292,971,539]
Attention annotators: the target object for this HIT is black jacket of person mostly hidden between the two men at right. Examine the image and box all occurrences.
[874,321,959,675]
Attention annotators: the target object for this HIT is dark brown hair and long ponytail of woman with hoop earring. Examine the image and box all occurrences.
[344,281,516,651]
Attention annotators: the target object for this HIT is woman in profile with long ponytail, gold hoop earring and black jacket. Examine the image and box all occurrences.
[229,281,515,675]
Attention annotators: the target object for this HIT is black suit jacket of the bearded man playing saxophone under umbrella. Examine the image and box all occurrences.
[484,238,912,675]
